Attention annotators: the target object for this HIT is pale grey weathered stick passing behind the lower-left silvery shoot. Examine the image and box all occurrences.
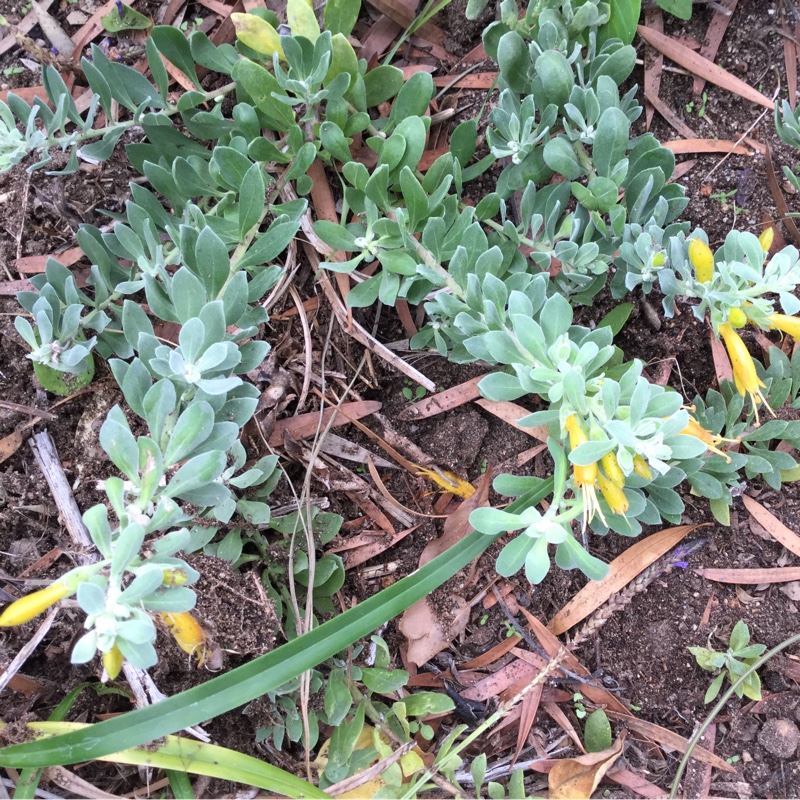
[30,430,211,742]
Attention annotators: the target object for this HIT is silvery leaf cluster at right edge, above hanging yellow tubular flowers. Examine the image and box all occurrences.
[658,231,800,331]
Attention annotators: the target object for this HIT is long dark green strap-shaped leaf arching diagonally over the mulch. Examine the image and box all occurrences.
[0,528,500,768]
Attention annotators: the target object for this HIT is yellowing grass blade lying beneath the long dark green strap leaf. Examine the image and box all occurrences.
[10,722,328,800]
